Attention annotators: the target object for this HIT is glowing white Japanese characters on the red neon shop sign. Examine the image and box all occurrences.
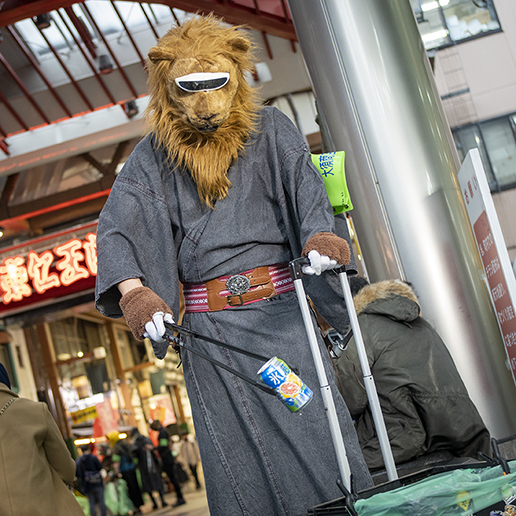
[0,233,97,305]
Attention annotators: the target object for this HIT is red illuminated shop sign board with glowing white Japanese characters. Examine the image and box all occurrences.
[0,224,97,313]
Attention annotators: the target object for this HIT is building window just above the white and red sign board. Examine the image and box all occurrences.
[452,114,516,192]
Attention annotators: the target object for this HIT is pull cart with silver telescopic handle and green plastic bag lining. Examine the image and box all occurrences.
[289,258,516,516]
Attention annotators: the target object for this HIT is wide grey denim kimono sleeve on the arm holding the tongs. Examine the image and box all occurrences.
[95,137,179,318]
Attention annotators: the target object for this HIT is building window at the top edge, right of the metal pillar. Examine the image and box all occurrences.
[411,0,501,50]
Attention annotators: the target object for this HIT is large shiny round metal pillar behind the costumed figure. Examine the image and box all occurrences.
[289,0,516,438]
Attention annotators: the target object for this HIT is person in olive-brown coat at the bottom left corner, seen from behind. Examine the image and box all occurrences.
[0,364,84,516]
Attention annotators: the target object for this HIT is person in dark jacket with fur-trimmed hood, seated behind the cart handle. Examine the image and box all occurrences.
[337,277,491,471]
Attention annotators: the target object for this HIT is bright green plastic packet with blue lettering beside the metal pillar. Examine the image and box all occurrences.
[310,151,353,215]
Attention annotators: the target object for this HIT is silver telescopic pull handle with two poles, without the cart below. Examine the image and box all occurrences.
[289,258,398,493]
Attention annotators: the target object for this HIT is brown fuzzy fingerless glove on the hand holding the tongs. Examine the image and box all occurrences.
[120,287,173,340]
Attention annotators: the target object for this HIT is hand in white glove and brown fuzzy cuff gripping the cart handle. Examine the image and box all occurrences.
[301,231,351,276]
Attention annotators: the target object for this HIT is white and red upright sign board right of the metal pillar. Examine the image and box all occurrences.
[458,149,516,382]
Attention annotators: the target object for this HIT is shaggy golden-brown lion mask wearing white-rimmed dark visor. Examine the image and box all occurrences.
[146,15,257,206]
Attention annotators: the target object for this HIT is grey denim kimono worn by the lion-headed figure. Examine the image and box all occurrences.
[96,108,371,516]
